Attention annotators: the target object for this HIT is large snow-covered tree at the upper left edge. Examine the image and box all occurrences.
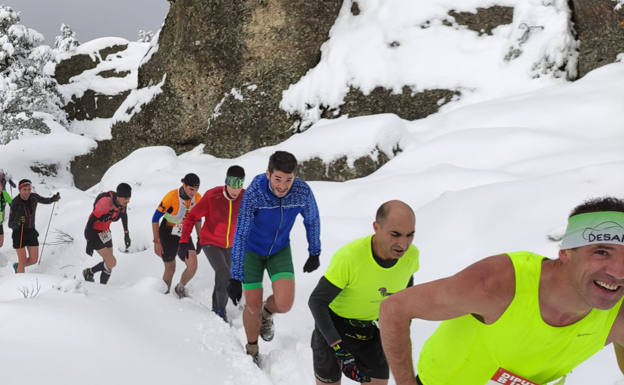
[0,6,67,144]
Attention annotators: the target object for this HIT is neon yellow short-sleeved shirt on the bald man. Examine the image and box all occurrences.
[325,235,418,321]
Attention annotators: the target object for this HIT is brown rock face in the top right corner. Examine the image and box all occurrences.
[570,0,624,77]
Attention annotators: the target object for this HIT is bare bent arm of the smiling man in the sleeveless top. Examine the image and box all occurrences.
[379,254,515,385]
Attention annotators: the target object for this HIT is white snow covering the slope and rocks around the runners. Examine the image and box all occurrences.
[0,1,624,385]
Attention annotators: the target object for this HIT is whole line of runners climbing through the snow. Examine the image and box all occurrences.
[0,151,624,385]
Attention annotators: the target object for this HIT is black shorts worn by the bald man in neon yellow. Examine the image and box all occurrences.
[311,313,390,383]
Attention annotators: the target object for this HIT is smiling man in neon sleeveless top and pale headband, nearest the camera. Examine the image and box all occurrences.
[379,198,624,385]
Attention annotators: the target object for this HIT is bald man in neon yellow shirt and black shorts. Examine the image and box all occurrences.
[308,201,418,385]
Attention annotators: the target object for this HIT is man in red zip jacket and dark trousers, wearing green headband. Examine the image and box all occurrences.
[178,166,245,322]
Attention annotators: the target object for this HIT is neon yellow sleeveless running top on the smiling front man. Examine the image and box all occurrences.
[418,251,622,385]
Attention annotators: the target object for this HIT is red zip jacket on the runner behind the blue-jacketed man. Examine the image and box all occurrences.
[180,186,245,249]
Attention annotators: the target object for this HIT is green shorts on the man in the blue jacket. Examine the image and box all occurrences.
[243,246,295,290]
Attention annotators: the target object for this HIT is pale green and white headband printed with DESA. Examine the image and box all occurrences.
[561,211,624,250]
